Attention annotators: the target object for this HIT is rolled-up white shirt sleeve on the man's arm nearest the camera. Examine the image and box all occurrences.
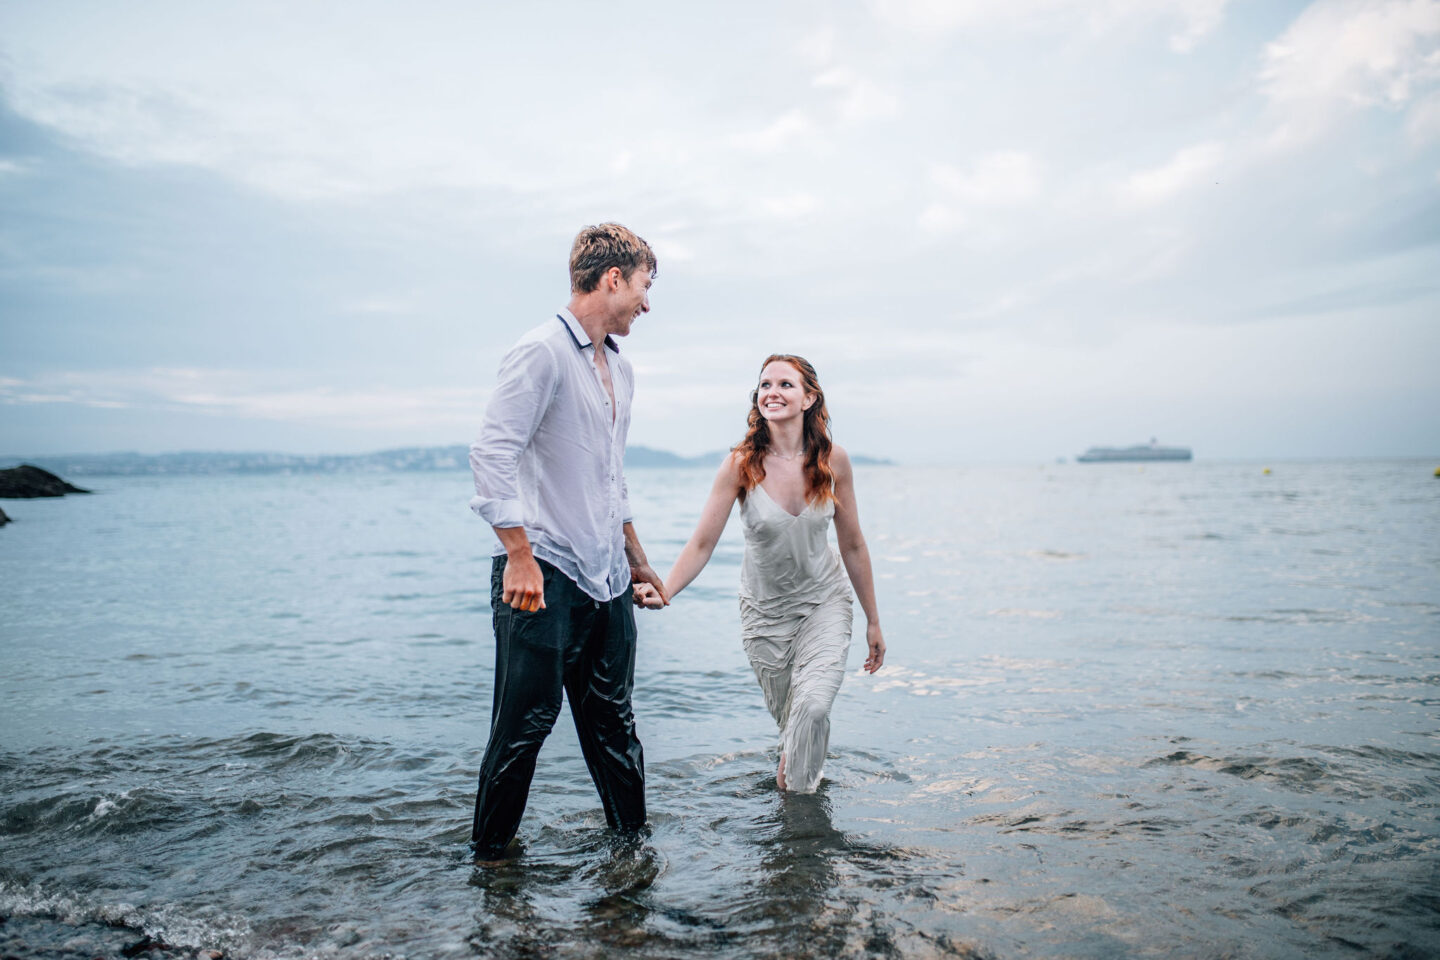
[469,341,559,527]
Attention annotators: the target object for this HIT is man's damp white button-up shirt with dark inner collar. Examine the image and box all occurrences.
[469,309,635,600]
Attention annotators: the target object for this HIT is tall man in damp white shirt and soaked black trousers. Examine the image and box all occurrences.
[469,223,668,861]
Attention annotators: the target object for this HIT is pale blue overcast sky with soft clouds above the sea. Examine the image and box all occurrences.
[0,0,1440,463]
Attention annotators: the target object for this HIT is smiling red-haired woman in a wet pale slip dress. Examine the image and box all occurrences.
[636,354,886,793]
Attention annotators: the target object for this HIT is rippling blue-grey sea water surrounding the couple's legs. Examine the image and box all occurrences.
[0,461,1440,957]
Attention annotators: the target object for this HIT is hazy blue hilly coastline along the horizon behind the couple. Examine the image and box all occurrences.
[0,445,894,476]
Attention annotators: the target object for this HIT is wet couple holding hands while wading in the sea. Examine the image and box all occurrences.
[469,223,886,861]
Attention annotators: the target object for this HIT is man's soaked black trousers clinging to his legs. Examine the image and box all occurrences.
[471,557,645,859]
